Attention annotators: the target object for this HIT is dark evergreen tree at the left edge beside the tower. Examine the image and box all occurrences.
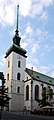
[0,72,10,119]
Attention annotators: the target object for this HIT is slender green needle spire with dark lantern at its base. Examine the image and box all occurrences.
[13,5,21,46]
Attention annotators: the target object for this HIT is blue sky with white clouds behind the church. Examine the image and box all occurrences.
[0,0,54,77]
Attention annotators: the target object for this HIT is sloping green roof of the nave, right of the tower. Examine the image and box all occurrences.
[25,68,54,86]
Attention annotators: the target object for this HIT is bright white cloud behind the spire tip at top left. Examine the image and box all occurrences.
[0,0,32,25]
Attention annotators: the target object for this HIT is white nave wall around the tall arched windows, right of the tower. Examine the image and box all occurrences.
[24,76,54,110]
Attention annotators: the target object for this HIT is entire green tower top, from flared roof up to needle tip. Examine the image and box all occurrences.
[5,5,27,58]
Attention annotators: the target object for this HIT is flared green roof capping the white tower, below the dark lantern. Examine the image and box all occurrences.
[5,43,27,58]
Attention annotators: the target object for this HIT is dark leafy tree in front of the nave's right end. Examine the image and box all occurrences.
[39,84,53,106]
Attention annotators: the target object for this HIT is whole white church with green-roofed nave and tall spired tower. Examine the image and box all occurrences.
[5,6,54,111]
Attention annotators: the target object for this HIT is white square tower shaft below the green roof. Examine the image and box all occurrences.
[6,52,26,111]
